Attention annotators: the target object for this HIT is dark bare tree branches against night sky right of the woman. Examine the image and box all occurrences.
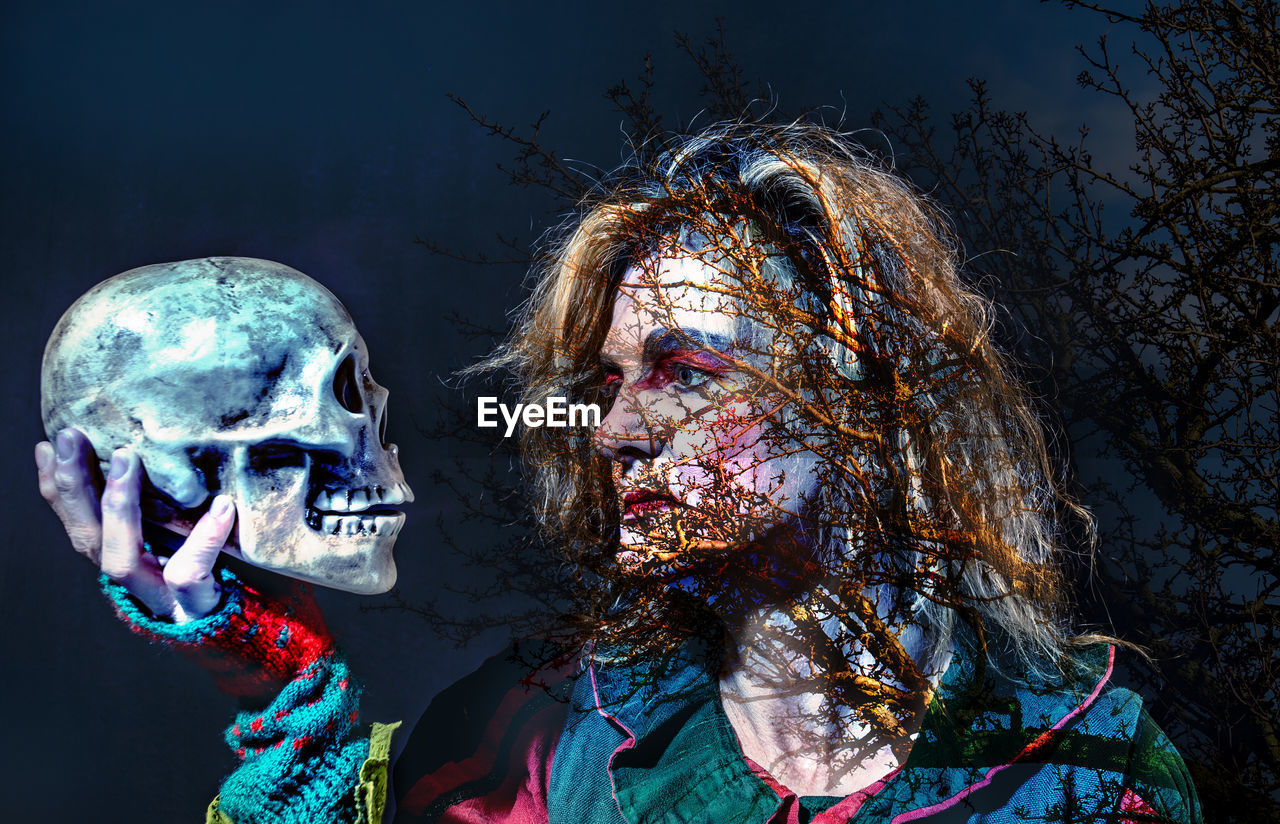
[879,0,1280,821]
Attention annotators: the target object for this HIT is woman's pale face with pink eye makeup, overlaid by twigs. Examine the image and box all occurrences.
[595,248,819,578]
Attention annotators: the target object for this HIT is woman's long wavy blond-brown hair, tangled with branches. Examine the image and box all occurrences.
[484,123,1092,670]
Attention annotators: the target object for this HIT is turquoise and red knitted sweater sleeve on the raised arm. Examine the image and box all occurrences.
[101,569,396,824]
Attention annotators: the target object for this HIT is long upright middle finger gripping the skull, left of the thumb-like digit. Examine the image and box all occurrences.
[102,448,173,617]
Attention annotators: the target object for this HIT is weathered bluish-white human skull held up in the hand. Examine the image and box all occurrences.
[41,257,413,594]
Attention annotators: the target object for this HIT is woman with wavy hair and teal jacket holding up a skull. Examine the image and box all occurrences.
[37,125,1199,821]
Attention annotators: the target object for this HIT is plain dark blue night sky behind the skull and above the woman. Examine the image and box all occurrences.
[0,0,1129,823]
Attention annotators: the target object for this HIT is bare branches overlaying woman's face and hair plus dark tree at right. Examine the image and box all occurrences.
[414,0,1280,821]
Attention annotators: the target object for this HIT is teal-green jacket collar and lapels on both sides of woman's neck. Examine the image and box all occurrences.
[584,645,1114,824]
